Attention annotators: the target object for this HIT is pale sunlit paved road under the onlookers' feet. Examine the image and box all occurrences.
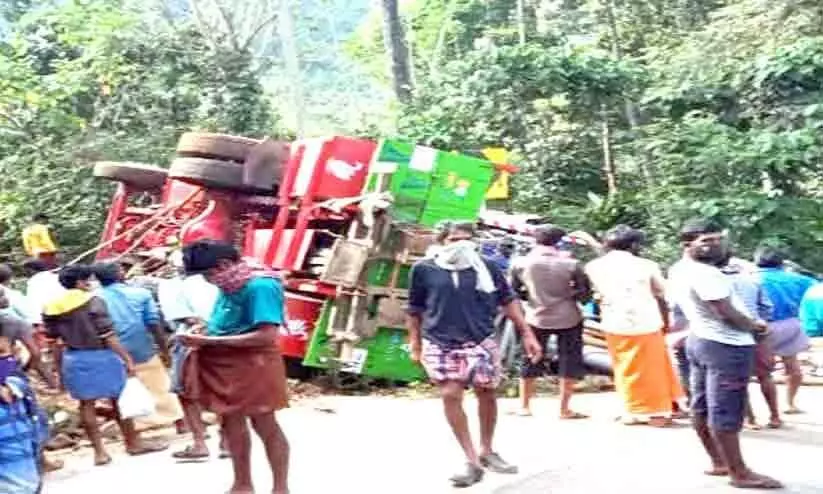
[45,388,823,494]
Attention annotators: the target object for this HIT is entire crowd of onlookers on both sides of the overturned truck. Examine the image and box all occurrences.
[0,213,823,494]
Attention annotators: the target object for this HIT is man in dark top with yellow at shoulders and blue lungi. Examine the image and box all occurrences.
[43,265,168,465]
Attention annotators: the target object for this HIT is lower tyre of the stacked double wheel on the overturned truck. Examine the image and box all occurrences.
[169,158,275,195]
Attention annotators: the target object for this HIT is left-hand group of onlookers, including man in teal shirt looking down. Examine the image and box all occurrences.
[0,217,289,494]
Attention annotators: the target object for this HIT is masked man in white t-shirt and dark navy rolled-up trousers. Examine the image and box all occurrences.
[669,219,782,489]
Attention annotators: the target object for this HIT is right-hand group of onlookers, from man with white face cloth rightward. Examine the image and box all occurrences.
[409,220,823,489]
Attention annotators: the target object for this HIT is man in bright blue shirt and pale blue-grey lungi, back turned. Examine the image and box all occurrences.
[755,247,817,414]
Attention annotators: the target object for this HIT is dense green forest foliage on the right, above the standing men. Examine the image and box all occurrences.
[386,0,823,269]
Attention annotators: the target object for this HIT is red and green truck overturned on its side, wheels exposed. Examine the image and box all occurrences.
[95,133,512,381]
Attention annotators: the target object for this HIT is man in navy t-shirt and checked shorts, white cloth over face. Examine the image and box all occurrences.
[408,223,540,487]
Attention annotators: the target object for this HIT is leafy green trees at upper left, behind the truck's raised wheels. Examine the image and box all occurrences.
[0,2,276,260]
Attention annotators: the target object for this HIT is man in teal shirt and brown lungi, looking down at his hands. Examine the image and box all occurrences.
[178,240,289,494]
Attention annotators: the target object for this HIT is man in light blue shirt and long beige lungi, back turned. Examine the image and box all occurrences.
[94,263,183,428]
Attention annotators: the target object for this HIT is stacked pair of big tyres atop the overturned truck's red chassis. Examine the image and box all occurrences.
[169,132,288,196]
